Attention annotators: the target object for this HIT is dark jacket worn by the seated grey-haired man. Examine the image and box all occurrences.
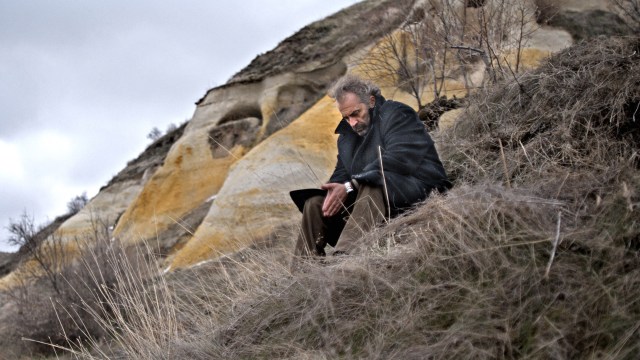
[329,96,451,214]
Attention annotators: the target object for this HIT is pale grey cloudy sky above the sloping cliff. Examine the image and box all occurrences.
[0,0,358,251]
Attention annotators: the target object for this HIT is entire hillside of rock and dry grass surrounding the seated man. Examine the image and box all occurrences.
[0,0,640,359]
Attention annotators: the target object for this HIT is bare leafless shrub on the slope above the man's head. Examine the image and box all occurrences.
[361,0,542,109]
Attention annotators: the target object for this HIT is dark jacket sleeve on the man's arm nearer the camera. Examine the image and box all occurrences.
[353,106,433,185]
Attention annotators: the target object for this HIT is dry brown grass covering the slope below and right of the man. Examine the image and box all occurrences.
[56,38,640,359]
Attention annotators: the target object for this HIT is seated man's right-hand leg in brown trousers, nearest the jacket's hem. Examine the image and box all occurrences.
[335,185,386,254]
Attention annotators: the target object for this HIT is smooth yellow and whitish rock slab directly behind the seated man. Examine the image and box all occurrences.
[172,97,340,268]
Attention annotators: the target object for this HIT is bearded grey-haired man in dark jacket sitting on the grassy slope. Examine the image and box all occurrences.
[292,75,451,256]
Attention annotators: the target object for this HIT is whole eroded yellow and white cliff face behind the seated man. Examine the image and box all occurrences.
[0,0,624,284]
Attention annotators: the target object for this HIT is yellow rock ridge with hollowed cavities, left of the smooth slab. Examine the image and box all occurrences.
[115,63,344,248]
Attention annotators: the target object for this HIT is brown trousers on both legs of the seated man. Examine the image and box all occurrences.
[295,185,386,256]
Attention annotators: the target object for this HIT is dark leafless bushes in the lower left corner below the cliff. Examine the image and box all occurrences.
[0,214,147,358]
